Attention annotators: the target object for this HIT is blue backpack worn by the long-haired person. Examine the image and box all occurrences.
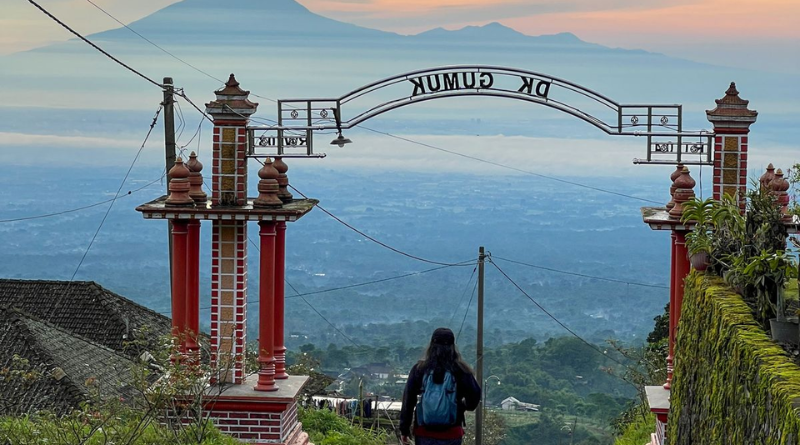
[417,370,458,427]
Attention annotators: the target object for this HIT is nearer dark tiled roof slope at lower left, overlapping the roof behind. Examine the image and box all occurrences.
[0,306,134,414]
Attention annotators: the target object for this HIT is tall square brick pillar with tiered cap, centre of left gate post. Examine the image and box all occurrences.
[206,74,258,384]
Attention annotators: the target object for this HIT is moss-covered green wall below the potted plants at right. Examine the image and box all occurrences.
[667,272,800,445]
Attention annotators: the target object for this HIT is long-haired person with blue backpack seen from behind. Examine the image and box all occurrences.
[400,328,481,445]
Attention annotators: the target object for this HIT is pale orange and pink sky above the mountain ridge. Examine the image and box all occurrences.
[0,0,800,73]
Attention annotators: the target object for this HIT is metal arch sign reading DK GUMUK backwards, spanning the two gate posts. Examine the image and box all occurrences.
[248,65,714,165]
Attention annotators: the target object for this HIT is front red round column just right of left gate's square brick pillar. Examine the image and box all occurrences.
[254,221,278,391]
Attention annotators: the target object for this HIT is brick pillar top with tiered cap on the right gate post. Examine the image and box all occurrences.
[706,82,758,205]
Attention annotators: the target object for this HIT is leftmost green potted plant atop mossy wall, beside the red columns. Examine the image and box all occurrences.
[681,198,717,271]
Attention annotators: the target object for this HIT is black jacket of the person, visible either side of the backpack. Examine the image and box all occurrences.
[400,364,481,436]
